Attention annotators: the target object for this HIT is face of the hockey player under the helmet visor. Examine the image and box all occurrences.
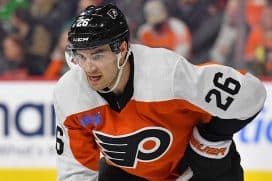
[75,45,118,90]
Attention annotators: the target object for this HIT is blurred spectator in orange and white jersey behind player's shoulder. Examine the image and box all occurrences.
[139,0,191,58]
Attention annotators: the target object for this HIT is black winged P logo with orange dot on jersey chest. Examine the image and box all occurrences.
[93,127,172,168]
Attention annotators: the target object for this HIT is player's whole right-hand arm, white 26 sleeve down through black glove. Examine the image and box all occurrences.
[173,59,266,180]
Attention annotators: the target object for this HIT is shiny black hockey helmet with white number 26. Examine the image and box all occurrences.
[68,4,129,53]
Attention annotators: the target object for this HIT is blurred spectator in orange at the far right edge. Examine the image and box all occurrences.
[245,3,272,75]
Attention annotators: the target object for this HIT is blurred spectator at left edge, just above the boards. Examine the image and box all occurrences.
[1,34,46,78]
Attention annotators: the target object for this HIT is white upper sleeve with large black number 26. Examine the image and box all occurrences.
[173,58,266,120]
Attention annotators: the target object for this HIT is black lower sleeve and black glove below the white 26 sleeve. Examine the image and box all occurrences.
[178,113,258,181]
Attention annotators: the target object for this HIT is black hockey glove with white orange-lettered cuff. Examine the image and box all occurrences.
[177,127,243,181]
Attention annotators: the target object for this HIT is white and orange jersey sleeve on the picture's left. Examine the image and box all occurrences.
[54,94,100,181]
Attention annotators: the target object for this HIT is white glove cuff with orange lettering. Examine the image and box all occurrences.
[190,127,232,159]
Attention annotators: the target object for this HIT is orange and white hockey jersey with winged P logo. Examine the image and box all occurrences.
[54,45,266,181]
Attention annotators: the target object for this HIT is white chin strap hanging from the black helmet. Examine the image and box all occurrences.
[97,48,131,93]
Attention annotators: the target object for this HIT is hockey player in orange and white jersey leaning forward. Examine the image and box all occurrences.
[54,5,266,181]
